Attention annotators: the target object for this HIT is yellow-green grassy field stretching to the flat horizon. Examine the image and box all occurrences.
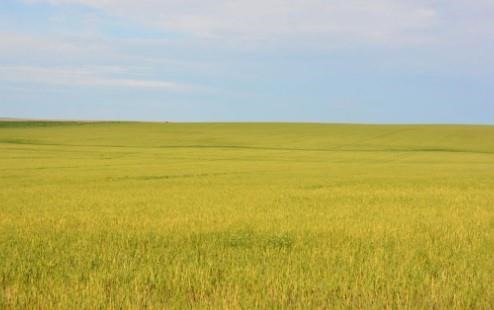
[0,122,494,309]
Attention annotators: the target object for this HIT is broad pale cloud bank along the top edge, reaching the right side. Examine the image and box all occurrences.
[17,0,494,48]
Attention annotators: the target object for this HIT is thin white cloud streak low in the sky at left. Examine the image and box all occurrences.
[0,65,195,91]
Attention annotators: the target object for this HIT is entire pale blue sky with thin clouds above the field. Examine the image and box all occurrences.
[0,0,494,124]
